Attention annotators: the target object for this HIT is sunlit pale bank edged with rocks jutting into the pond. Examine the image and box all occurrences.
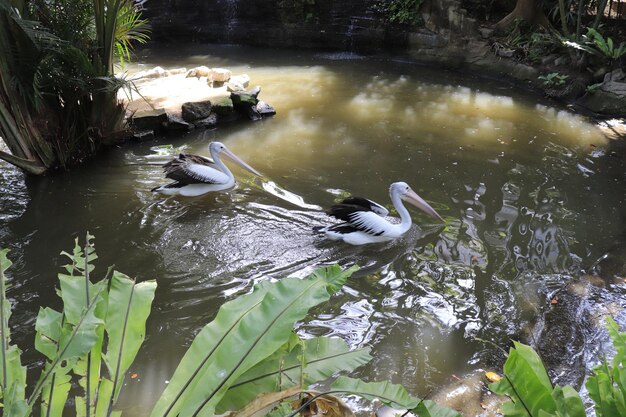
[119,66,276,141]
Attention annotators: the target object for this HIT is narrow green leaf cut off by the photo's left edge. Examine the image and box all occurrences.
[0,249,30,417]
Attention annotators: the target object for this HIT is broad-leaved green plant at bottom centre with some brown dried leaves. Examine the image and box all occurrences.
[151,265,460,417]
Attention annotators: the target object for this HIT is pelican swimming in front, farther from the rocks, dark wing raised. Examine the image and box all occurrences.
[320,182,443,245]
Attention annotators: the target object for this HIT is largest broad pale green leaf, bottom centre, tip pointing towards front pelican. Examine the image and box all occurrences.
[151,267,356,417]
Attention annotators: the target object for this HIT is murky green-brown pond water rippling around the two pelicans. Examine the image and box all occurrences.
[0,46,626,415]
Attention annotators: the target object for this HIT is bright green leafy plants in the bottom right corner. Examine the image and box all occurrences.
[489,317,626,417]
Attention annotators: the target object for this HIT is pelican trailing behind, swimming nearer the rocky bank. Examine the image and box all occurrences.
[152,142,261,197]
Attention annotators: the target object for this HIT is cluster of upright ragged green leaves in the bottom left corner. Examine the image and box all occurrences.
[0,234,156,417]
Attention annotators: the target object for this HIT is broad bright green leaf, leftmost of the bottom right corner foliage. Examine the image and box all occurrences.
[489,342,556,417]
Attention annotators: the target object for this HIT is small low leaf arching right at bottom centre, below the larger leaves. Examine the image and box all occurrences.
[330,376,420,410]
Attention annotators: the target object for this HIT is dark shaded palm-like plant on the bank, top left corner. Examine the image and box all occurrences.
[0,0,148,174]
